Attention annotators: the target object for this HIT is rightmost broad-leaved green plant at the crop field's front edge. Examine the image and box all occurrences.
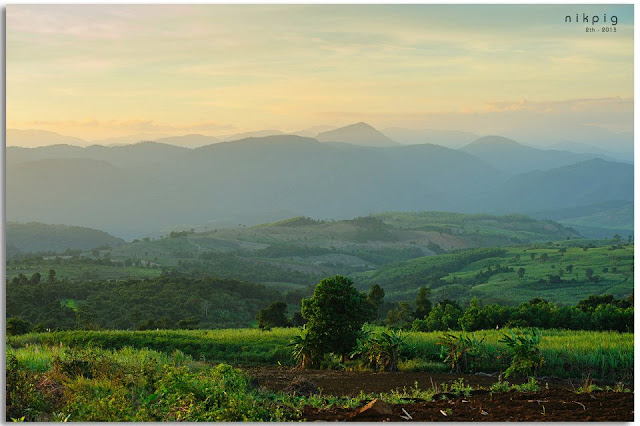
[500,328,544,377]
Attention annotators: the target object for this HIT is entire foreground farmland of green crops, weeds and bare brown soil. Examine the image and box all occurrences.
[7,329,633,421]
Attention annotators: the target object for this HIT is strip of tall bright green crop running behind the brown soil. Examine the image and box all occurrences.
[8,328,633,381]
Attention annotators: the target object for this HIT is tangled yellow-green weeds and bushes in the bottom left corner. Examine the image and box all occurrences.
[7,347,297,422]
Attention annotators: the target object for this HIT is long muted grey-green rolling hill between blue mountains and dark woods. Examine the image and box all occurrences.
[7,212,579,291]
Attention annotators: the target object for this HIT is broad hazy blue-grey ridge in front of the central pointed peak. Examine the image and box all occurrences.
[7,135,499,238]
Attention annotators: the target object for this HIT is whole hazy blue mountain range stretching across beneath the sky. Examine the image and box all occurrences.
[6,123,633,238]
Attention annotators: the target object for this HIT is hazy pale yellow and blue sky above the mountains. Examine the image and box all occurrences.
[7,5,633,139]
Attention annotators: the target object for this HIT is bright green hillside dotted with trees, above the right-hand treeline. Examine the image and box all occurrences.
[354,240,633,305]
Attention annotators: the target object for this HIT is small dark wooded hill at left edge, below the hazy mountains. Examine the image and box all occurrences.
[6,222,124,257]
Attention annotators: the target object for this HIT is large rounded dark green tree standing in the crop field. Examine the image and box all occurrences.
[302,275,374,360]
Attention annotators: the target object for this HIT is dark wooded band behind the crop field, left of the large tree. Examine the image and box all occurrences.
[6,273,284,334]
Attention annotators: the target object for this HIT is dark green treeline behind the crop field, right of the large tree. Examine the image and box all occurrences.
[385,287,633,332]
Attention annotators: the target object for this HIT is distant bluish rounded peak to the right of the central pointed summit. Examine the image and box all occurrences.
[461,136,599,175]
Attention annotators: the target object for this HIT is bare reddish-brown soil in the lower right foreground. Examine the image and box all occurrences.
[245,367,634,422]
